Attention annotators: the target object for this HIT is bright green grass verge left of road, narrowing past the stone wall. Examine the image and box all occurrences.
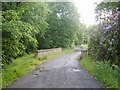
[2,50,72,88]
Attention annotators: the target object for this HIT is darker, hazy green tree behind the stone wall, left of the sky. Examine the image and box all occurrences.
[39,2,82,48]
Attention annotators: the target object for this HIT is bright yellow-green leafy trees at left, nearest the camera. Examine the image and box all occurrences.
[2,2,50,65]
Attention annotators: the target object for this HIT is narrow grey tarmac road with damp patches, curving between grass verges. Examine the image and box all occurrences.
[9,52,102,88]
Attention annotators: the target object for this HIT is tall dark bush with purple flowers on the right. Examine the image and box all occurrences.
[89,2,120,65]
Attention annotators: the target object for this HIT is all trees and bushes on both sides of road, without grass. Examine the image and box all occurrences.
[2,2,120,68]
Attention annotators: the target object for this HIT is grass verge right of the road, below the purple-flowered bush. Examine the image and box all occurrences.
[80,56,118,88]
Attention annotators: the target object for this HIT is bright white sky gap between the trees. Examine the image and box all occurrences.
[73,0,102,25]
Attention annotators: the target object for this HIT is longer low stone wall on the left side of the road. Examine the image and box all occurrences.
[34,48,62,57]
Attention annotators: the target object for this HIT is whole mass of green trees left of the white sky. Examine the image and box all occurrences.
[2,2,85,64]
